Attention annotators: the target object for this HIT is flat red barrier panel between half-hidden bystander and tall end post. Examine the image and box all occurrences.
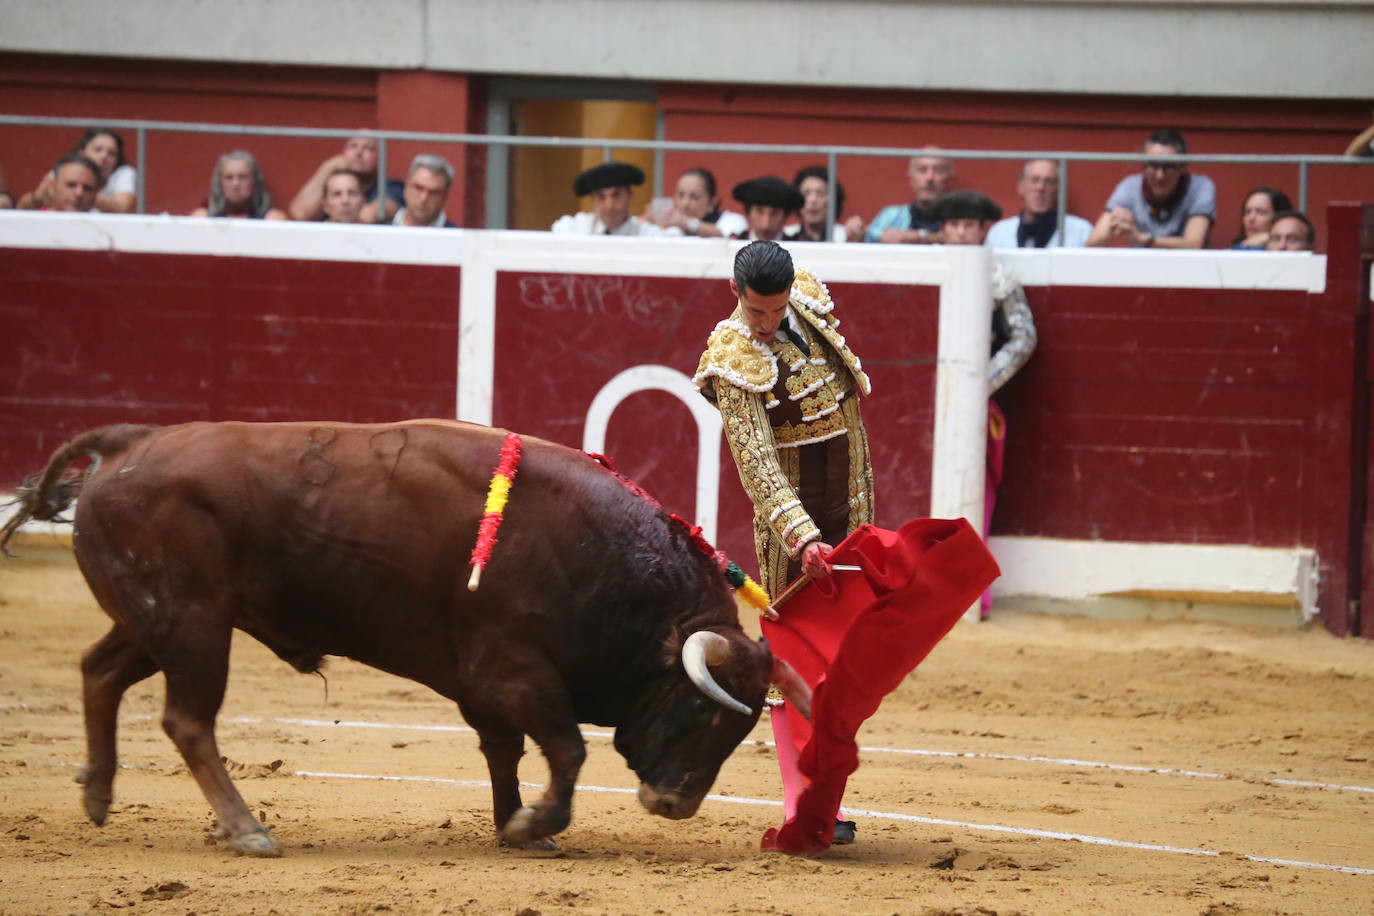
[993,287,1324,547]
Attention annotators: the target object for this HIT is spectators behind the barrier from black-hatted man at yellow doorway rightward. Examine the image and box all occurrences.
[541,128,1315,250]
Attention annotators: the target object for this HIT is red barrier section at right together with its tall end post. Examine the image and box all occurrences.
[991,203,1374,636]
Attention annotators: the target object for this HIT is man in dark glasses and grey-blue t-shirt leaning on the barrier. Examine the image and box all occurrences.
[1088,128,1216,249]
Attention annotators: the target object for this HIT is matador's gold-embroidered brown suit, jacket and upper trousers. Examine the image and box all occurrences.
[692,269,872,596]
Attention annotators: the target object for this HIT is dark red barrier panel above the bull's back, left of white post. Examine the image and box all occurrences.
[0,247,460,477]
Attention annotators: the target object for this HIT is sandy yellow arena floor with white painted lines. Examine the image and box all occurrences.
[0,548,1374,916]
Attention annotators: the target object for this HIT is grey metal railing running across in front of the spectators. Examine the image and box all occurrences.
[0,114,1374,238]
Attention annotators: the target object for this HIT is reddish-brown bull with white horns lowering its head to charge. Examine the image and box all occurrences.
[0,420,802,856]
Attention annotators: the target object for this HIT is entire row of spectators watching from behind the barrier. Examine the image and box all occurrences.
[0,128,1341,250]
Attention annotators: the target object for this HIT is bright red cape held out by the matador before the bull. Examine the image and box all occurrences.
[761,519,999,853]
